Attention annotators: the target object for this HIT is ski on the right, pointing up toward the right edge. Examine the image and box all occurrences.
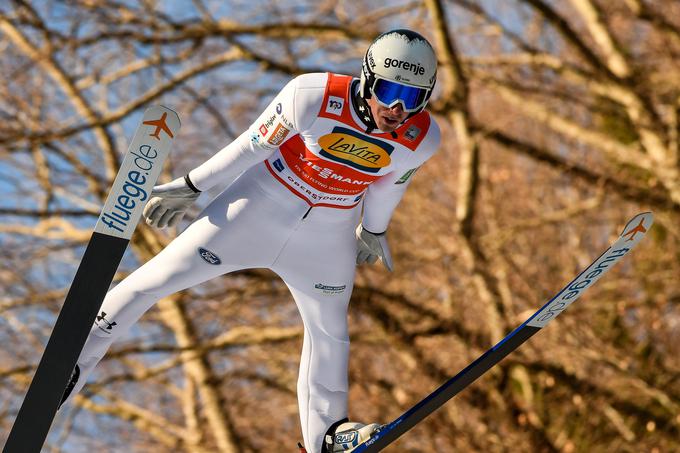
[354,212,654,453]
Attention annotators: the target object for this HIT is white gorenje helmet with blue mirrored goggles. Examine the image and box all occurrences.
[359,29,437,113]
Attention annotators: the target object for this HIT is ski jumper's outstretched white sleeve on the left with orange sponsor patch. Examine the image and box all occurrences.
[189,74,327,191]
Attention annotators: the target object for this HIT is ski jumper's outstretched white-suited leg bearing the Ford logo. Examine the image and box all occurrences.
[71,181,298,395]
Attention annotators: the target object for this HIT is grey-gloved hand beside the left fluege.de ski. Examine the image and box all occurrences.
[144,178,201,228]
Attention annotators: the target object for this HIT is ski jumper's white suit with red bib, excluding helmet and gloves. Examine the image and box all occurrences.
[72,73,440,453]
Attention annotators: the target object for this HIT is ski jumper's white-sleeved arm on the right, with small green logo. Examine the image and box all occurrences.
[362,119,440,234]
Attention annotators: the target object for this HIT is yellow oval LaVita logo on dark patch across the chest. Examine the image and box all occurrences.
[319,126,394,173]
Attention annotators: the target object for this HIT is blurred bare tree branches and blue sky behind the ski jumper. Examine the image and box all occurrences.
[0,0,680,452]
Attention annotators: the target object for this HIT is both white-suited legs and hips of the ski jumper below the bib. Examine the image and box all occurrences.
[73,171,358,453]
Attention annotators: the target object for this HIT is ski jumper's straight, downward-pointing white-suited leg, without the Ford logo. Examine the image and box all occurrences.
[272,216,356,453]
